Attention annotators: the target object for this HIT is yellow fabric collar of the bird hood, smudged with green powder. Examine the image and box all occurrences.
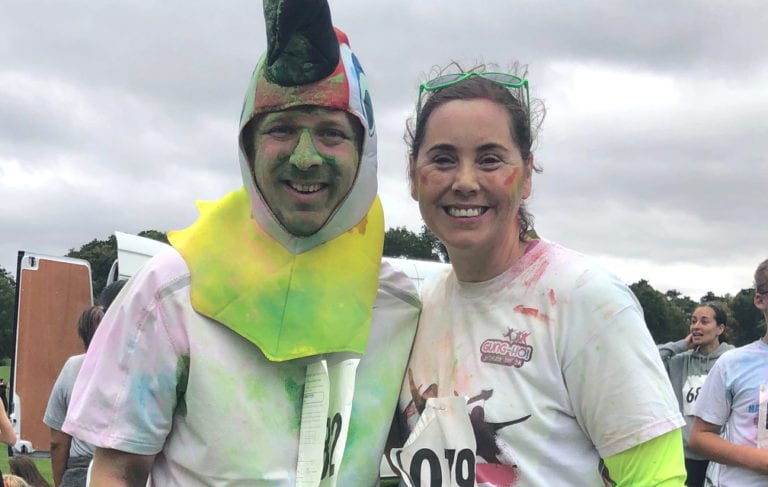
[168,188,384,361]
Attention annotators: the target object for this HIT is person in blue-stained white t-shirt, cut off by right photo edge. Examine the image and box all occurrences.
[689,259,768,487]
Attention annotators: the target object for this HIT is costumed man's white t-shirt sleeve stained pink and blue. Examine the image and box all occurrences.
[64,257,189,455]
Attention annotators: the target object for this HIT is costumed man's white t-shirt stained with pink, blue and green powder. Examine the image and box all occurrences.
[64,249,420,487]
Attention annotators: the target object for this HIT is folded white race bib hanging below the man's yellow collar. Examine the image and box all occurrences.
[296,358,360,487]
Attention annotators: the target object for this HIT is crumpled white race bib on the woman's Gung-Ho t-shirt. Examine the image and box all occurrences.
[389,396,477,487]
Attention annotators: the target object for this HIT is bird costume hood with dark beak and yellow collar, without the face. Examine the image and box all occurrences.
[169,0,384,361]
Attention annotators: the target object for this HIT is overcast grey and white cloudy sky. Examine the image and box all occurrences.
[0,0,768,299]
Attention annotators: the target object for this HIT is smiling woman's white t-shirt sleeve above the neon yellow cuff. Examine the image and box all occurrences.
[563,275,684,458]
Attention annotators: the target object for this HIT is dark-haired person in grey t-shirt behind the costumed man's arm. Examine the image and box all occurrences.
[43,305,104,487]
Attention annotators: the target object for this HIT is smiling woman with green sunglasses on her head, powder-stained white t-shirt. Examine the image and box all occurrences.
[388,68,685,487]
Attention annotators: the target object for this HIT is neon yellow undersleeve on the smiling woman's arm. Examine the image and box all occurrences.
[605,429,686,487]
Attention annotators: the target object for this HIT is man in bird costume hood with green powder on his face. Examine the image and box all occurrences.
[64,0,419,486]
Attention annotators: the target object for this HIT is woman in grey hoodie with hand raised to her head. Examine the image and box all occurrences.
[659,302,734,487]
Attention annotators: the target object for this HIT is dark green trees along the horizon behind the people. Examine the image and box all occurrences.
[0,226,765,358]
